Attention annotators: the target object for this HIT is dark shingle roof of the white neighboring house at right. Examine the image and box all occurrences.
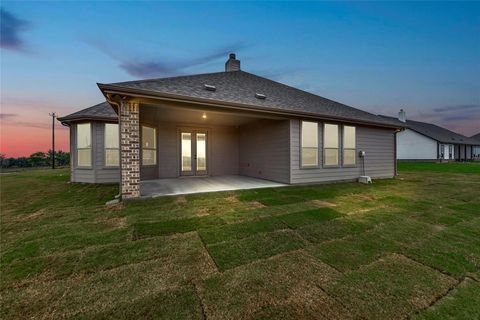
[381,115,476,144]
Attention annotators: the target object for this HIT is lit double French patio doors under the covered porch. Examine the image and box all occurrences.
[180,130,208,176]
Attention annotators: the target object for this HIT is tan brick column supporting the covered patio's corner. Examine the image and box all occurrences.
[118,101,140,199]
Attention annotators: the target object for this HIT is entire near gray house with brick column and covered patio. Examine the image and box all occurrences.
[59,54,402,198]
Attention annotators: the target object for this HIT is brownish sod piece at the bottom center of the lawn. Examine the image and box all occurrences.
[199,250,349,319]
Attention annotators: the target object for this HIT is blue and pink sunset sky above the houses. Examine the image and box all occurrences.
[0,1,480,157]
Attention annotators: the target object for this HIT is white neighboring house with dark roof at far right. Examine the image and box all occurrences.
[382,109,476,161]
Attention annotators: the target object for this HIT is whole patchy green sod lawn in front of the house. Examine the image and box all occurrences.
[0,163,480,319]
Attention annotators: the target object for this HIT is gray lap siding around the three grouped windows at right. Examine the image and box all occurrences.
[290,120,395,184]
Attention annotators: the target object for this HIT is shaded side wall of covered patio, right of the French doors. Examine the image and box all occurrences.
[239,120,290,183]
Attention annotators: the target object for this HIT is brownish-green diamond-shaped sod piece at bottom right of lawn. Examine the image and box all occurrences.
[325,254,457,319]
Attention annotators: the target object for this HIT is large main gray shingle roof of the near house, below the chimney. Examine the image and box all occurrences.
[98,71,403,128]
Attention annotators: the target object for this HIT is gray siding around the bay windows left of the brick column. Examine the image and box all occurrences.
[70,122,120,183]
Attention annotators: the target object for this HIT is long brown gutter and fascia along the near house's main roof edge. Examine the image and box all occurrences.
[97,83,402,129]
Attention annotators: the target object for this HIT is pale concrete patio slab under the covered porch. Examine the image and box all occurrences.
[140,175,286,198]
